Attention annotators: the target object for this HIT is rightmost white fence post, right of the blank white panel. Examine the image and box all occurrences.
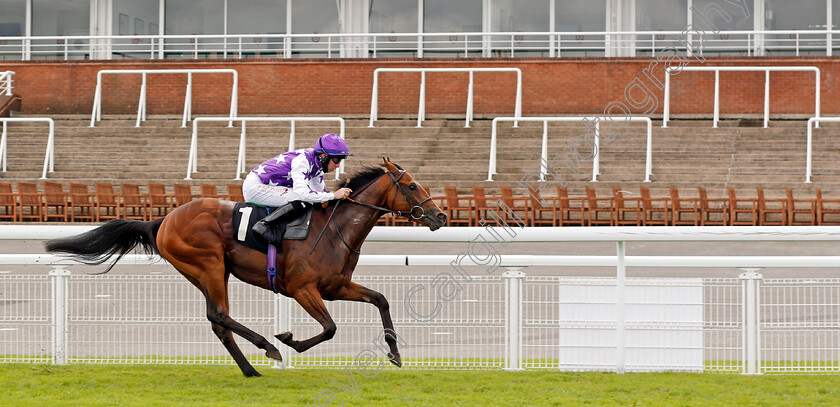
[738,268,763,374]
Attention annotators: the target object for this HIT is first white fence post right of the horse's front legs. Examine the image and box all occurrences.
[502,267,525,372]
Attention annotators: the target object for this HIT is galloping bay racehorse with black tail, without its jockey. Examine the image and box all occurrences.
[45,158,446,377]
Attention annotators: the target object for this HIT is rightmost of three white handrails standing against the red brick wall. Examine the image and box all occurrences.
[662,66,820,128]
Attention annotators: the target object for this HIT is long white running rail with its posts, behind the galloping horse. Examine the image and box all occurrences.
[8,225,840,374]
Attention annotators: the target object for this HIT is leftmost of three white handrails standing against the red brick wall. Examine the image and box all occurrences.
[90,69,239,127]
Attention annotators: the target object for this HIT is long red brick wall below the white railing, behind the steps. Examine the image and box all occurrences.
[0,57,840,117]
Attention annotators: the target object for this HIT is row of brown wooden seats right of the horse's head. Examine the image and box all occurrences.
[435,186,840,226]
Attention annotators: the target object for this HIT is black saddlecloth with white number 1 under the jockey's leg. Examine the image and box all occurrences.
[231,202,314,253]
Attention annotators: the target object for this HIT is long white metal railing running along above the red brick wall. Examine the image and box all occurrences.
[0,30,840,60]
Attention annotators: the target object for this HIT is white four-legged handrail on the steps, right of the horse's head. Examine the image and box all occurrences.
[487,116,653,182]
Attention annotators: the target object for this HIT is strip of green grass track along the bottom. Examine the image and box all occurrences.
[0,364,840,407]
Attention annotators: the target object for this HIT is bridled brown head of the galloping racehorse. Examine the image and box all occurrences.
[381,158,446,230]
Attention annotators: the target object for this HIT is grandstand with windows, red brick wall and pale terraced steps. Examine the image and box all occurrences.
[0,0,840,224]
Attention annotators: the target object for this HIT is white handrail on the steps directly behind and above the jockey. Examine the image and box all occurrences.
[189,116,345,180]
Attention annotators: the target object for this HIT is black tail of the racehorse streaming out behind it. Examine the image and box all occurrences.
[44,218,163,273]
